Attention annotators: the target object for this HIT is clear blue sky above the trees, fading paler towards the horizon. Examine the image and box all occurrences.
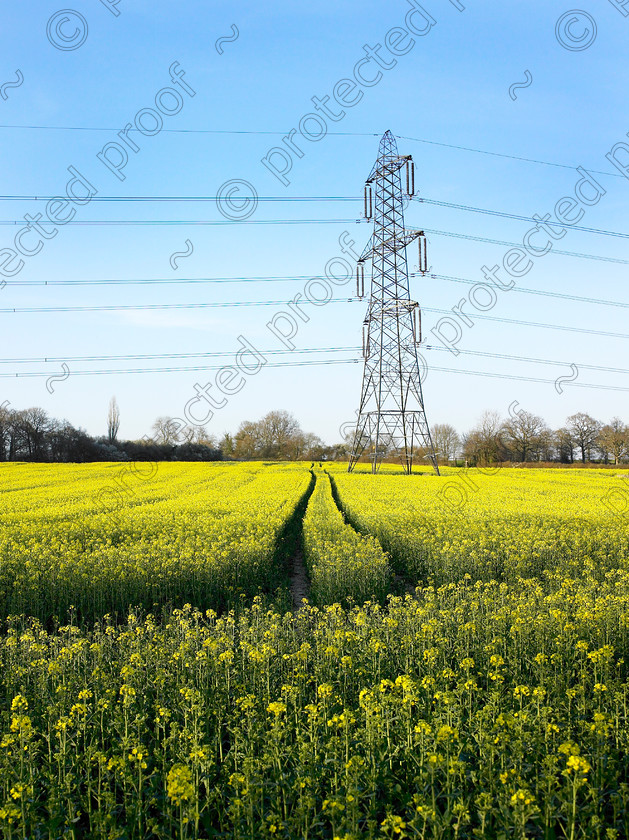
[0,0,629,442]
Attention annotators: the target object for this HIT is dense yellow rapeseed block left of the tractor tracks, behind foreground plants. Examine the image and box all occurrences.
[0,463,310,620]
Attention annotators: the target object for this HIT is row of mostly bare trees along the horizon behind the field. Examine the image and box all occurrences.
[0,398,629,465]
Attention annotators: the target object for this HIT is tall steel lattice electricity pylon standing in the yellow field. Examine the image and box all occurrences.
[349,131,439,474]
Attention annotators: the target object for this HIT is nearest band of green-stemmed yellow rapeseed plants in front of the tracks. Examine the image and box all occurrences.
[0,573,629,840]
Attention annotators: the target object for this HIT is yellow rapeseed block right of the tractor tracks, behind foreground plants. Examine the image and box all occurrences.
[333,469,629,584]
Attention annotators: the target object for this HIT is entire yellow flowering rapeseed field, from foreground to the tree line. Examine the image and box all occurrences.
[0,464,629,840]
